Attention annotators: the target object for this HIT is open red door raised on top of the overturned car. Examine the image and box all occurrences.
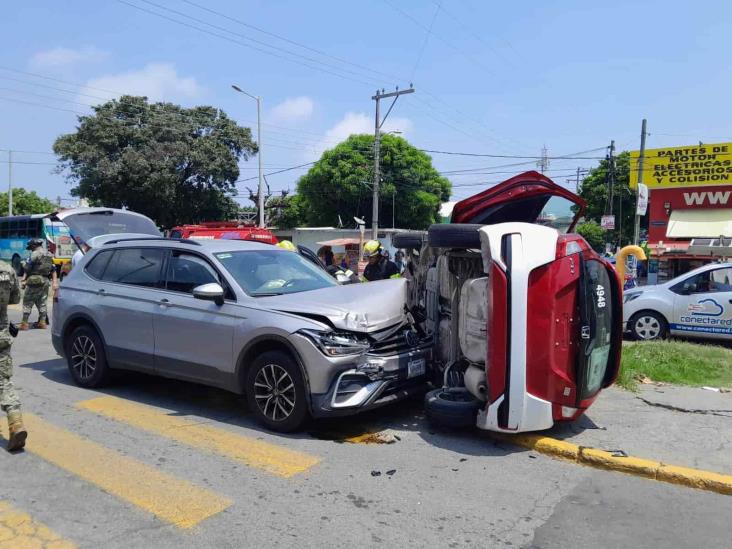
[451,171,587,233]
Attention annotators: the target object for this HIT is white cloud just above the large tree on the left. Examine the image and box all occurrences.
[86,63,202,101]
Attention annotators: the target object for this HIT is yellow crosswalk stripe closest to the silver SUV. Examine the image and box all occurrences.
[76,396,320,478]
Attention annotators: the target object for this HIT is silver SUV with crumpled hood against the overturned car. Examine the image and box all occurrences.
[52,216,431,432]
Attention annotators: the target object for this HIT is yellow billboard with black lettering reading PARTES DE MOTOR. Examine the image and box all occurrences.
[630,143,732,189]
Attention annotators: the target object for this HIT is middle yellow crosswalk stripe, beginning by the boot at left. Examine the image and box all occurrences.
[4,414,232,528]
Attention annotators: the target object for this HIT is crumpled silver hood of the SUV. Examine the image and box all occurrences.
[255,279,407,333]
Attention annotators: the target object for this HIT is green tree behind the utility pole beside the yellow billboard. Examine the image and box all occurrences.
[579,152,635,247]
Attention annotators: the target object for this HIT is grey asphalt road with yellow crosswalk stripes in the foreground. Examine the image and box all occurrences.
[0,311,732,549]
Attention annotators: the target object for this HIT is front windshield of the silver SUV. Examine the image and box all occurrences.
[216,250,338,297]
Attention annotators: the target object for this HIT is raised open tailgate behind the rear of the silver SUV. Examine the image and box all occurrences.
[50,208,163,242]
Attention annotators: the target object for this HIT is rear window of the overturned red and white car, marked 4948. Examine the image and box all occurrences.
[577,260,615,400]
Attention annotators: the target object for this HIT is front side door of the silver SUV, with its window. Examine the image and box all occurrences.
[154,249,240,386]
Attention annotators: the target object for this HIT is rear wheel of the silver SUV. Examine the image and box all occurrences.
[65,325,110,388]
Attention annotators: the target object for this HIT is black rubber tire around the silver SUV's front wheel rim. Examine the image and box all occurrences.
[244,351,310,433]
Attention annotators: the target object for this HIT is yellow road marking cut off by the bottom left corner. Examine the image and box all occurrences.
[0,501,76,549]
